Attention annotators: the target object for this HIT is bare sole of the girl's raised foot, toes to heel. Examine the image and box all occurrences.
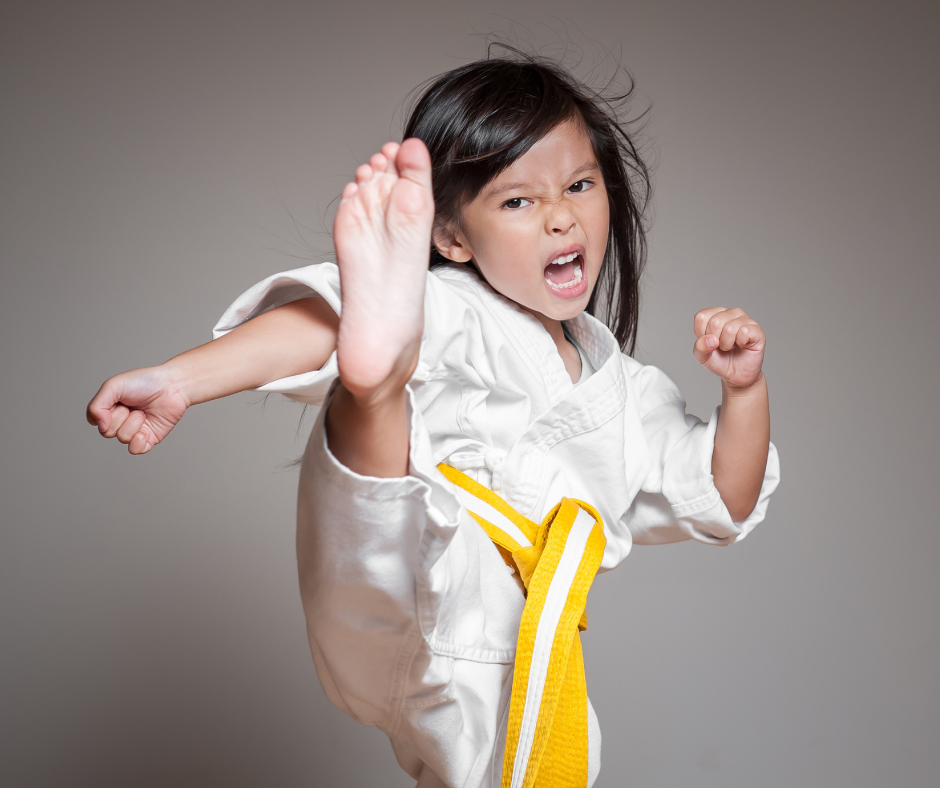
[333,139,434,398]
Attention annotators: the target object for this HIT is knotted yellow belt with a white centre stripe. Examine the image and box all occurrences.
[437,463,607,788]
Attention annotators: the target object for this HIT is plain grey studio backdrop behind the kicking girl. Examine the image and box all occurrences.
[0,0,940,788]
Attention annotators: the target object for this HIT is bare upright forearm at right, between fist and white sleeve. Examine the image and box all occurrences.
[712,373,770,522]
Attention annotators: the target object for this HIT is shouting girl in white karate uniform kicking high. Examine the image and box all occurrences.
[88,58,778,788]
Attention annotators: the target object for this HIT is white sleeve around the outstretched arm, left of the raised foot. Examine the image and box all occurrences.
[212,263,341,405]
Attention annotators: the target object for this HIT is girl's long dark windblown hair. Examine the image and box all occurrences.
[404,47,650,353]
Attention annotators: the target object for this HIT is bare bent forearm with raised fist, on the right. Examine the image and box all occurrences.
[692,307,770,522]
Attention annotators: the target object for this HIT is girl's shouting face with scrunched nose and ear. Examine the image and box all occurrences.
[436,116,610,320]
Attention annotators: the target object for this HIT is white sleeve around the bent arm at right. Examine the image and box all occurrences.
[624,356,780,545]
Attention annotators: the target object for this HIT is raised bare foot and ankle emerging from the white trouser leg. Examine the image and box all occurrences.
[327,139,434,477]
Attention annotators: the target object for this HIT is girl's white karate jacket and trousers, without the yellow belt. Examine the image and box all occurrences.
[214,263,779,788]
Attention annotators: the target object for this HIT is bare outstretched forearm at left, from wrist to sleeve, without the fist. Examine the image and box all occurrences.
[163,297,339,405]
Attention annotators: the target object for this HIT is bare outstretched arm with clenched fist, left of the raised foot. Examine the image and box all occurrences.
[86,297,339,454]
